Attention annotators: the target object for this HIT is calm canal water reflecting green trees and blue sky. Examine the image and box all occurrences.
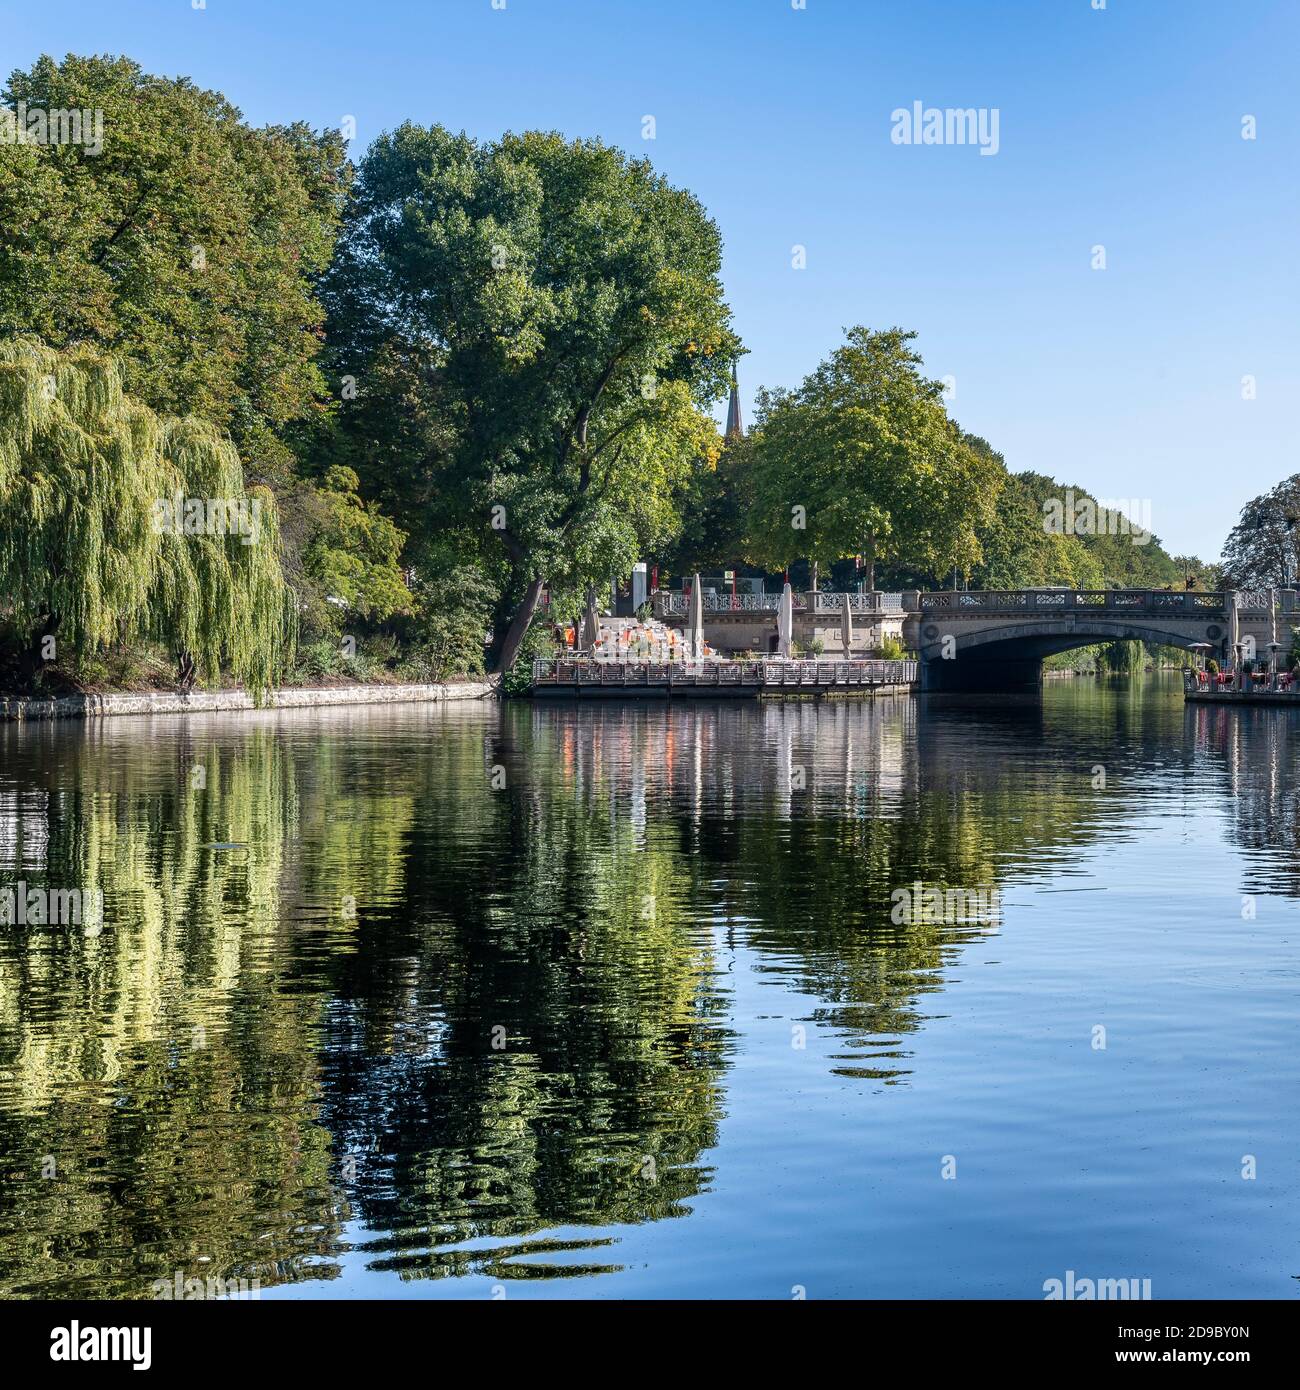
[0,676,1300,1298]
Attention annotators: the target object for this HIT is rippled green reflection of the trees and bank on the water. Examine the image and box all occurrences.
[0,689,1297,1297]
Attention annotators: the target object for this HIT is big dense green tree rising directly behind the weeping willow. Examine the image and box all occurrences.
[0,56,348,481]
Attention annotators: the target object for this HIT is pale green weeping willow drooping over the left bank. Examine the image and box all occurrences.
[0,338,296,694]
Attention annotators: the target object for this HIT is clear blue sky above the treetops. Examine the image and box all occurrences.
[0,0,1300,559]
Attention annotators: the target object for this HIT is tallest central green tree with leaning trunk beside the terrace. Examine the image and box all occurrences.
[327,125,738,670]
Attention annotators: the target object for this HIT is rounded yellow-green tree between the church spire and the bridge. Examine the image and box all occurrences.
[747,327,1005,587]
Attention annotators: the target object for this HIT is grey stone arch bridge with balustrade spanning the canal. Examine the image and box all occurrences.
[902,589,1284,691]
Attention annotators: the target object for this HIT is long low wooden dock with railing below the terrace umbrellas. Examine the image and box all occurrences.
[533,657,916,699]
